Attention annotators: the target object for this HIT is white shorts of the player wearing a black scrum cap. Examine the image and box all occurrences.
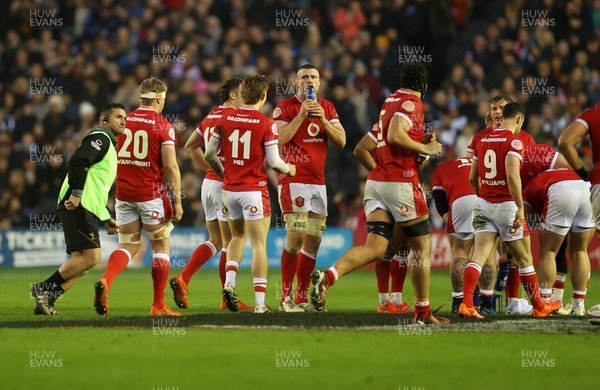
[363,180,429,222]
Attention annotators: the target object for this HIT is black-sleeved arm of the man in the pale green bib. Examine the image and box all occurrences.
[65,134,110,210]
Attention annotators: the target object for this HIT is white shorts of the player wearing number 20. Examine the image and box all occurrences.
[115,195,173,226]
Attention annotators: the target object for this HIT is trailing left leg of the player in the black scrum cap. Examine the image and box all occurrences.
[311,209,393,311]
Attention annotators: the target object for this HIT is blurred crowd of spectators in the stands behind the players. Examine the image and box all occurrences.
[0,0,600,232]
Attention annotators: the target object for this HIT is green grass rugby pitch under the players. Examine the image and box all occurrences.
[0,269,600,390]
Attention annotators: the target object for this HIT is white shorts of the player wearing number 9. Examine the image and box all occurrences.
[473,198,529,242]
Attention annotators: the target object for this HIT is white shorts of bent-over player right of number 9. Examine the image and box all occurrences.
[542,180,594,236]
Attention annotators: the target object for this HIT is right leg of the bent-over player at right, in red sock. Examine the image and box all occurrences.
[568,229,594,316]
